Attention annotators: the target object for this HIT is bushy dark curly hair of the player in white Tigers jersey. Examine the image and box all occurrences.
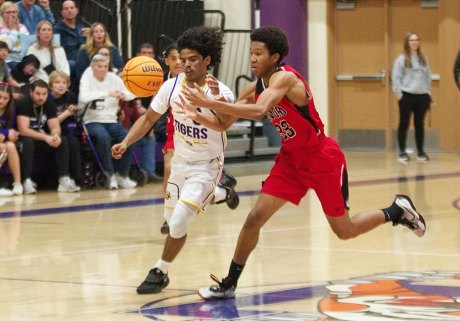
[177,26,224,67]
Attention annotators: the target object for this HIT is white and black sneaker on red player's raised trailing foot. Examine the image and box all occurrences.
[393,195,426,237]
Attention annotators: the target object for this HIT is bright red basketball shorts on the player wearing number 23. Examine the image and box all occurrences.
[261,137,349,216]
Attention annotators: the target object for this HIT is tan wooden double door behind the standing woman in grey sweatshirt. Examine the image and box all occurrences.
[333,0,439,150]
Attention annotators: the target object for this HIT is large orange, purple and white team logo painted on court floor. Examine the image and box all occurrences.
[128,272,460,321]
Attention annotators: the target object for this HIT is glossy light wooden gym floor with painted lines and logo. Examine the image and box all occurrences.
[0,152,460,321]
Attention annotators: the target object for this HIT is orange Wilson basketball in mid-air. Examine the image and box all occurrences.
[122,56,163,97]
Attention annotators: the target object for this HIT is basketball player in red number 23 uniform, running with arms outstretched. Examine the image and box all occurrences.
[182,27,426,299]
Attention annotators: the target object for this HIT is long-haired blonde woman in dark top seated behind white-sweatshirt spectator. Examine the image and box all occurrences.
[73,22,124,91]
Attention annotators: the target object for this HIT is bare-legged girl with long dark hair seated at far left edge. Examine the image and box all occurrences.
[0,83,23,195]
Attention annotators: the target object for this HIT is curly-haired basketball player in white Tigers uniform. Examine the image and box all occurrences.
[112,27,236,294]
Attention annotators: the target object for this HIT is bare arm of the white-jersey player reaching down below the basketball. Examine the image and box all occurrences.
[112,108,161,159]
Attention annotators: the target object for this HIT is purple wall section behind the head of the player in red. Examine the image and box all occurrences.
[256,0,308,78]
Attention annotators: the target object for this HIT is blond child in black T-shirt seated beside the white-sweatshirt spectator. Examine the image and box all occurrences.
[49,70,82,183]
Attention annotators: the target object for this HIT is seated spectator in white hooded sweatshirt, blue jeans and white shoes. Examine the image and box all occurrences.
[78,55,137,189]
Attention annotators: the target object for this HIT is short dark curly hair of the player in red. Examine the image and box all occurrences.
[251,26,289,64]
